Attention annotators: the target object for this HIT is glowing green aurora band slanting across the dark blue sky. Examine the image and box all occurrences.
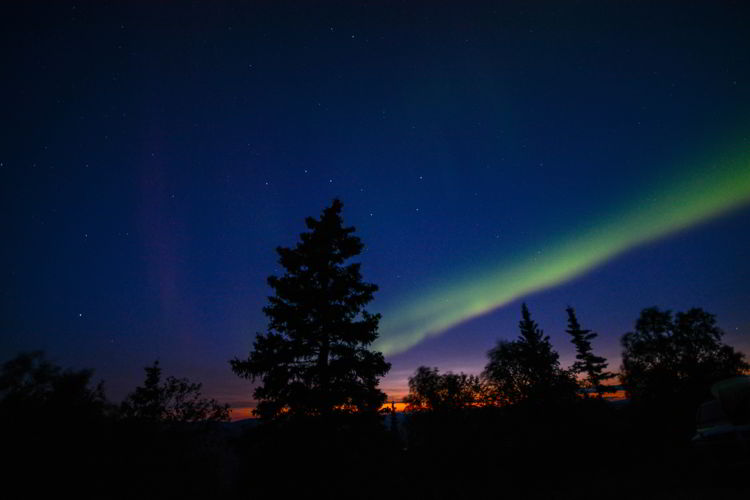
[374,148,750,355]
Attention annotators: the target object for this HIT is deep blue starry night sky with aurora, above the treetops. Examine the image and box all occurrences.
[0,1,750,416]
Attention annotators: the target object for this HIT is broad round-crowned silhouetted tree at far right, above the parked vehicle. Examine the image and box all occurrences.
[621,307,749,404]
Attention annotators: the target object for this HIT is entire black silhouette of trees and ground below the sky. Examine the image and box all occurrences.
[0,200,750,499]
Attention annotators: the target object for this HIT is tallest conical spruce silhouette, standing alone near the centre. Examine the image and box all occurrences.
[231,199,390,419]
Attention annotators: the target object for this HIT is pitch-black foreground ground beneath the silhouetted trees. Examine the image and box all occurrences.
[2,401,750,499]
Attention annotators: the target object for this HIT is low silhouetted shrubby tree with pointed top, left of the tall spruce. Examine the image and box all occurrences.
[120,361,229,423]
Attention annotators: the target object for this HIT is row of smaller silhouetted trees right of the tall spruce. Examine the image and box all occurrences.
[405,304,750,418]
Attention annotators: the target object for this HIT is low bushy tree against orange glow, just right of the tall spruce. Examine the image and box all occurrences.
[404,366,483,411]
